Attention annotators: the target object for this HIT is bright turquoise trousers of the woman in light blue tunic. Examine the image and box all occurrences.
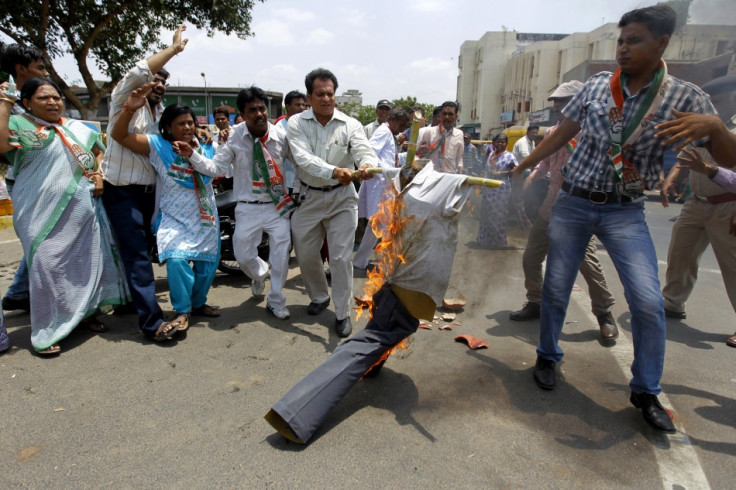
[166,259,217,313]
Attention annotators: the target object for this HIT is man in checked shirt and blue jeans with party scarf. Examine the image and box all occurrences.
[513,5,716,433]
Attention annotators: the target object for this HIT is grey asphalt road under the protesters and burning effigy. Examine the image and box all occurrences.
[0,193,736,489]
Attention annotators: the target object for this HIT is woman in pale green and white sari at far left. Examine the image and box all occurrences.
[0,78,129,355]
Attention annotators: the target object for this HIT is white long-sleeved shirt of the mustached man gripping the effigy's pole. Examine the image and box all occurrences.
[289,109,377,187]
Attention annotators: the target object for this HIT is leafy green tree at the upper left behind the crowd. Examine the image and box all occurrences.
[0,0,265,118]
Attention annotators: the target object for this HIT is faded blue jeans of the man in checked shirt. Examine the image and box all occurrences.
[537,192,666,395]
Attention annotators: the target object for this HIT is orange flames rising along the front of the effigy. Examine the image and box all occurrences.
[356,186,411,320]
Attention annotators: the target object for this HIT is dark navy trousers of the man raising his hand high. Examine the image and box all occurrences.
[102,182,163,335]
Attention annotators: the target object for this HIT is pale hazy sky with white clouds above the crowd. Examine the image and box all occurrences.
[27,0,736,105]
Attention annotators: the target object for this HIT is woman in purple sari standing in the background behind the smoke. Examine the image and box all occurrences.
[476,133,517,249]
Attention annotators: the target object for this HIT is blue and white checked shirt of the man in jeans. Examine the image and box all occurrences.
[562,72,716,192]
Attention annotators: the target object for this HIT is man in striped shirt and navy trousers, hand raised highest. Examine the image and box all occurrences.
[102,26,187,339]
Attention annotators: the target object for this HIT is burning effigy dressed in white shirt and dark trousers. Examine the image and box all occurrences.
[265,163,470,444]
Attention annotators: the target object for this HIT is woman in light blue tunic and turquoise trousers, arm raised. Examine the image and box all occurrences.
[110,84,220,332]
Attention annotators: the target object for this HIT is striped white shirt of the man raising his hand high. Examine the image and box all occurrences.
[102,60,163,185]
